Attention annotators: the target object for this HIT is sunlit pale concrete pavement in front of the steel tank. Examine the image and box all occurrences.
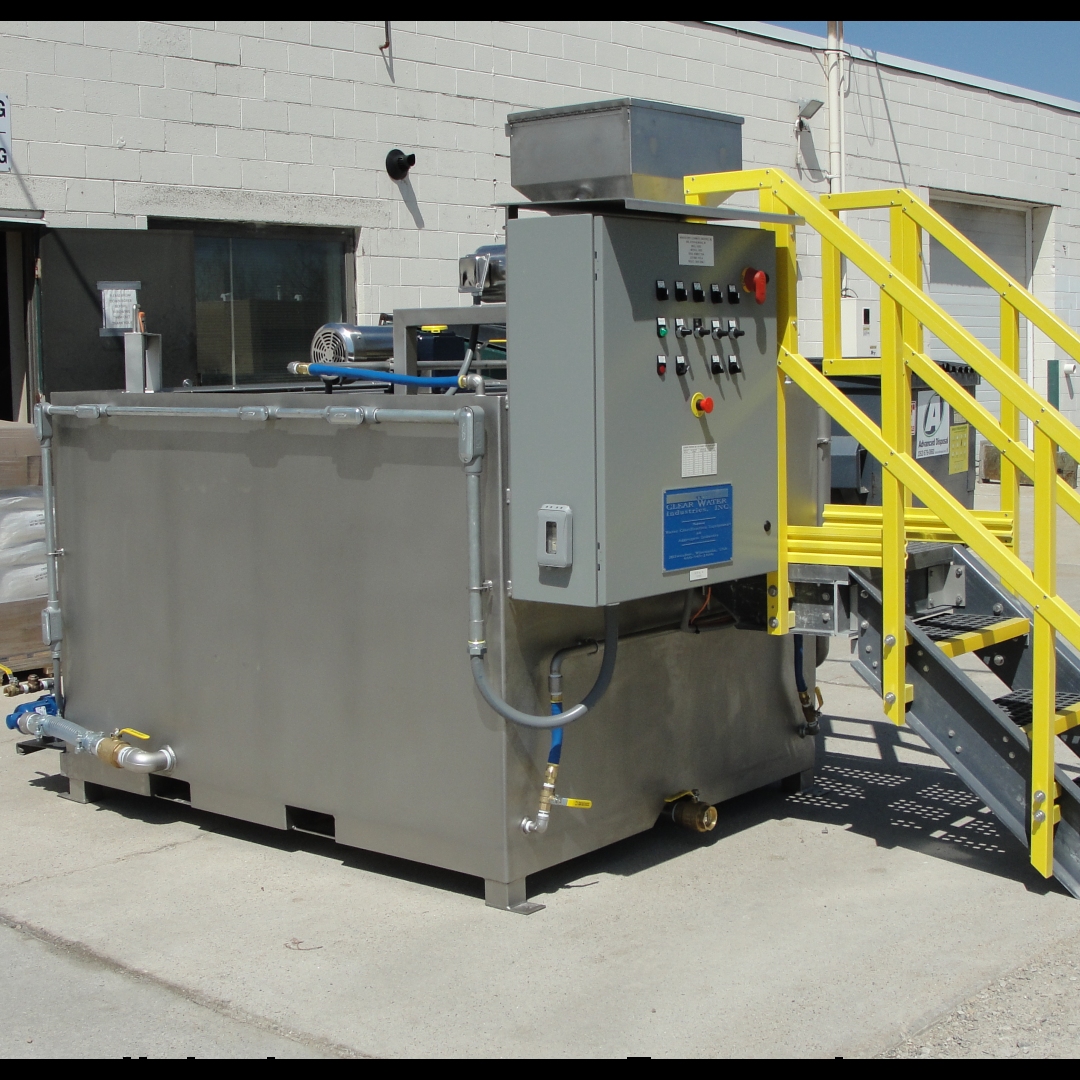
[6,486,1080,1056]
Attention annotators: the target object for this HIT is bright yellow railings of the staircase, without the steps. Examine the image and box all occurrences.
[684,168,1080,877]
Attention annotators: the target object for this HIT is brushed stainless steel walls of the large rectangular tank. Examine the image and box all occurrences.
[54,393,813,881]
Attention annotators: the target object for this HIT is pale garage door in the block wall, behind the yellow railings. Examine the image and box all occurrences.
[926,199,1028,436]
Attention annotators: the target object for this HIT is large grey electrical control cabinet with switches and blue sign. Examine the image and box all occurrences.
[507,213,778,607]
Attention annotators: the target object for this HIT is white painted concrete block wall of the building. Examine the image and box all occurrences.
[0,21,1080,404]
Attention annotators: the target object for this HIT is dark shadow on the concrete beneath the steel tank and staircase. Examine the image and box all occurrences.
[19,716,1062,897]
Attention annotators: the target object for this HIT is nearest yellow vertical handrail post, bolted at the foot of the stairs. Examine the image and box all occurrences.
[1029,431,1057,877]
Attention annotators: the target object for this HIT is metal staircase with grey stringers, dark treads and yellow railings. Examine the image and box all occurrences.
[684,168,1080,896]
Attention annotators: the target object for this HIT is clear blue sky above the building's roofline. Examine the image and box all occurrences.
[771,22,1080,102]
